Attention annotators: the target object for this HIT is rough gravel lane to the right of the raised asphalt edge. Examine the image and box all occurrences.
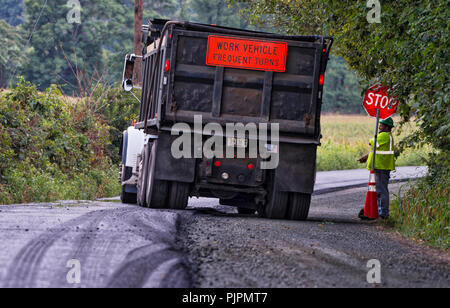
[182,184,450,288]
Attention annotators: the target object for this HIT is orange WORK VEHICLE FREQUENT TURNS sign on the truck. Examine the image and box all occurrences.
[206,35,288,73]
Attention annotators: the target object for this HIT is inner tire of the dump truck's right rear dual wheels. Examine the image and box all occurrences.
[259,172,289,219]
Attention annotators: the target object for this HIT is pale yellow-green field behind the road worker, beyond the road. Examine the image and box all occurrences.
[317,115,429,171]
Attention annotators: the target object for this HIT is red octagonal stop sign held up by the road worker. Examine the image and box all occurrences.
[363,86,398,120]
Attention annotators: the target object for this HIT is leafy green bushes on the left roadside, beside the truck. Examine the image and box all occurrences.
[0,80,118,204]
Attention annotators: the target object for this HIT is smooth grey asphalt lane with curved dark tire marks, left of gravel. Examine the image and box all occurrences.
[0,202,191,287]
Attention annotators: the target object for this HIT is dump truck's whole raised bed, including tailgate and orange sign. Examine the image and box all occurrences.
[138,24,331,142]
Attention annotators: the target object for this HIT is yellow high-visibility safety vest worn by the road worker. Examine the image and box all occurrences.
[367,133,395,171]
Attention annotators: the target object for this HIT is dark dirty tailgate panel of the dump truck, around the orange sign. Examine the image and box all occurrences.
[165,29,324,137]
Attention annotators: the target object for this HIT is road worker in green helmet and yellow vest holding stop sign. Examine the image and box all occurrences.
[359,118,395,220]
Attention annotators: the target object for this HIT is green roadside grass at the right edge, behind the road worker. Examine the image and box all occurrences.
[388,174,450,250]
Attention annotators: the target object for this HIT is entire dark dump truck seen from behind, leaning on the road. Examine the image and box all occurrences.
[121,20,333,220]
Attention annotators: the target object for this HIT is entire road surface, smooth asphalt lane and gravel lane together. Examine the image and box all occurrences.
[0,184,450,288]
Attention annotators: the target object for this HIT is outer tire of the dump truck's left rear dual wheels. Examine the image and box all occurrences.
[145,140,169,209]
